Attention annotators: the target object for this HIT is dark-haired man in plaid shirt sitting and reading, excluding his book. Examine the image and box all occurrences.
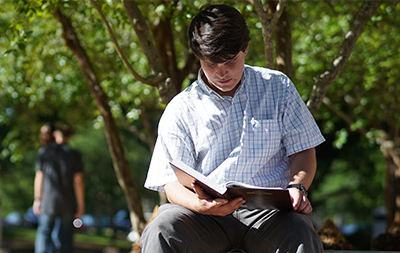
[141,5,324,253]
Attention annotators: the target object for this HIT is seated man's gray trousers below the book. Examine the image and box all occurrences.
[140,204,323,253]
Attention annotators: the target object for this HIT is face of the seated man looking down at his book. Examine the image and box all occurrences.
[200,48,248,96]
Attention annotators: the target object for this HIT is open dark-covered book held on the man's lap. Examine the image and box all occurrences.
[170,159,292,210]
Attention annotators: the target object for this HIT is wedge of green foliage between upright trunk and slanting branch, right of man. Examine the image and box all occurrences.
[288,1,358,96]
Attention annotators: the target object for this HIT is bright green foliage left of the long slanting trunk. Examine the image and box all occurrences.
[0,2,94,162]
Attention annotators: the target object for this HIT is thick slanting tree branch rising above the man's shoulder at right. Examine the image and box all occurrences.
[307,0,383,115]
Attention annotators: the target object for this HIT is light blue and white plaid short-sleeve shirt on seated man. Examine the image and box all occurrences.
[145,65,324,191]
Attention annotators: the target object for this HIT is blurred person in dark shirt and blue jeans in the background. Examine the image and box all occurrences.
[33,125,85,253]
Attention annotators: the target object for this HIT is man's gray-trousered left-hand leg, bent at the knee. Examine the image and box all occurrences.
[141,204,234,253]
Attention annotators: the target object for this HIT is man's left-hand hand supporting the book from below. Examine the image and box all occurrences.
[192,184,246,216]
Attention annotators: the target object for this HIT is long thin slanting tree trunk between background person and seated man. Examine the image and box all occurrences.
[54,10,146,234]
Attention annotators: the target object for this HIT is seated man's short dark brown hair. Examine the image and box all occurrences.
[189,5,250,63]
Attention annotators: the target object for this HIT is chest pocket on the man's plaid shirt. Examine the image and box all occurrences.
[242,118,281,160]
